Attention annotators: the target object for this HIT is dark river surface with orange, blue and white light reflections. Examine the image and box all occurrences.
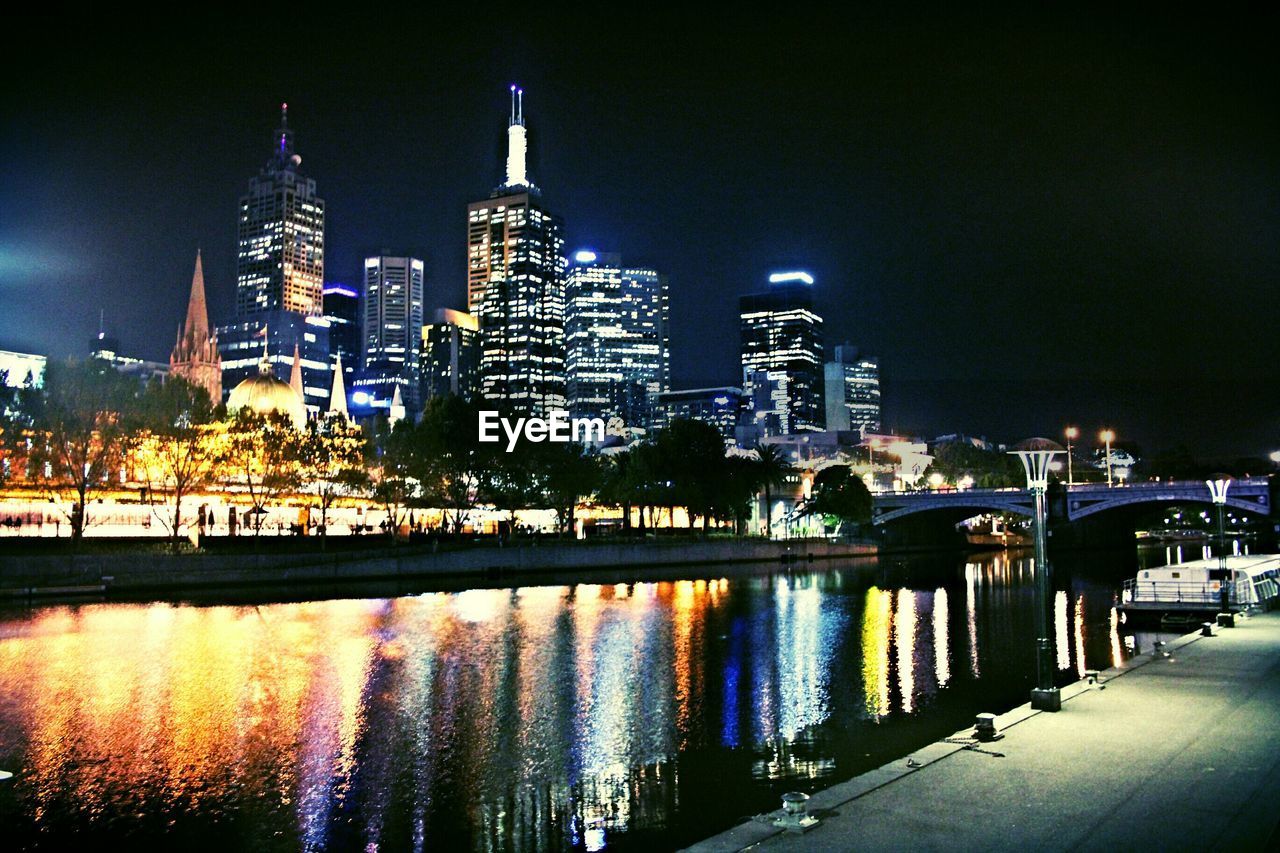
[0,548,1177,850]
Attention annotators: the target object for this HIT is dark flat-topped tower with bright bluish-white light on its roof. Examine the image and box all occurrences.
[739,272,826,434]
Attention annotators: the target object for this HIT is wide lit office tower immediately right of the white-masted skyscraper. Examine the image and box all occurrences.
[564,251,671,428]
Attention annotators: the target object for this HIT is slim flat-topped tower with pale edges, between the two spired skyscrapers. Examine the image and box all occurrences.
[355,255,424,412]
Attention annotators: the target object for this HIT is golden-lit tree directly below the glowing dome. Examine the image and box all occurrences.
[218,409,302,537]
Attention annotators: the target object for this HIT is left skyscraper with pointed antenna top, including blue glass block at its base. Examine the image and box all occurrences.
[216,104,333,412]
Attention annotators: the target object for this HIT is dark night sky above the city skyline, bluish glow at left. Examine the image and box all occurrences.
[0,13,1280,455]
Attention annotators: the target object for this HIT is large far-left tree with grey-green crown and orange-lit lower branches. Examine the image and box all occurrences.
[20,359,138,542]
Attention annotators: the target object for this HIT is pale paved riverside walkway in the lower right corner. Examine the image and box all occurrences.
[689,612,1280,853]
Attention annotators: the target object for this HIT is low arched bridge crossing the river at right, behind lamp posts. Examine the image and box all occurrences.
[872,478,1272,524]
